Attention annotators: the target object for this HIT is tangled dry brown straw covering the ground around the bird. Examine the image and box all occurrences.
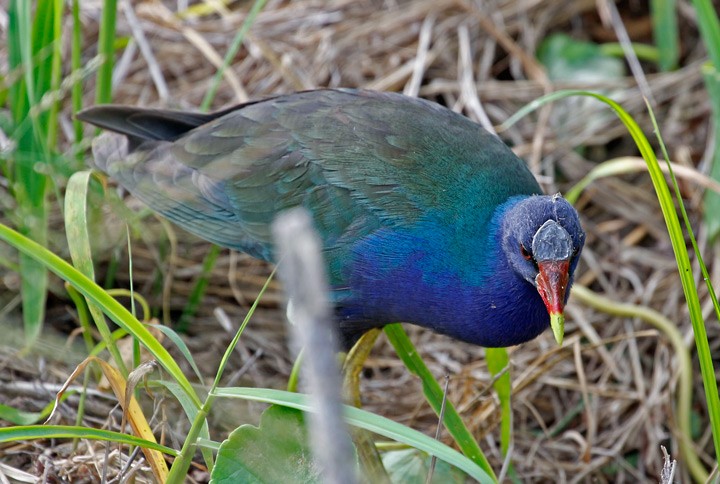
[0,0,720,482]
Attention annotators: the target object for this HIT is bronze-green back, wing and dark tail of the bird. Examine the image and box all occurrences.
[80,90,539,267]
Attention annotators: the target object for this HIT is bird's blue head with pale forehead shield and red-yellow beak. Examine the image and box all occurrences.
[502,195,585,343]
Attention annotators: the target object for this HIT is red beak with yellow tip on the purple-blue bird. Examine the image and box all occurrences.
[535,260,570,344]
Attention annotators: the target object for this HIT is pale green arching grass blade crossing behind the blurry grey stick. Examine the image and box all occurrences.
[214,388,496,483]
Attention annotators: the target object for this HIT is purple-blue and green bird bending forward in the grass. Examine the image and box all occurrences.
[78,89,585,347]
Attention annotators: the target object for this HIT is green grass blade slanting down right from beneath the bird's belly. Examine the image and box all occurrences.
[385,324,497,480]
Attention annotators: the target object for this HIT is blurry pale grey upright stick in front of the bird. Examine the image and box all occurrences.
[272,208,357,484]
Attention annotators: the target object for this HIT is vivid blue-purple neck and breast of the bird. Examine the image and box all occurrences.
[342,199,550,346]
